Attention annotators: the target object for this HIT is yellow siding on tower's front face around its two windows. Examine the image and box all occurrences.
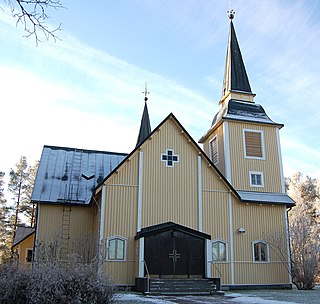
[229,122,282,192]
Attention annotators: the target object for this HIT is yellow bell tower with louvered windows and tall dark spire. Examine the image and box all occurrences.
[199,10,285,193]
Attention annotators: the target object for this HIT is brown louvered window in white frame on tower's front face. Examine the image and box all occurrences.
[243,130,265,159]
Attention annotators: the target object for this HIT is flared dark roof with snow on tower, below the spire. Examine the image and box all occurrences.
[212,99,283,127]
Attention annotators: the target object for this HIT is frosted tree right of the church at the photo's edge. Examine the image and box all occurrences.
[287,172,320,289]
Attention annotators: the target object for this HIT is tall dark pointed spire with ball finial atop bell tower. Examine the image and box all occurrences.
[222,10,252,98]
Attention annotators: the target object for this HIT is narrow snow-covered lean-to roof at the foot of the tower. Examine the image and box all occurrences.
[237,190,295,207]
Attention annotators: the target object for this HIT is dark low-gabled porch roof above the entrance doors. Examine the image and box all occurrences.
[135,222,211,240]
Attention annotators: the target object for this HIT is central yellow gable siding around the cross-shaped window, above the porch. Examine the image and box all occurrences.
[142,120,198,229]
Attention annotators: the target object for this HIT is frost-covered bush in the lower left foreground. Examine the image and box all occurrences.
[0,263,114,304]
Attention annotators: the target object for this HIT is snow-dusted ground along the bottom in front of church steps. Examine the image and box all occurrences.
[115,286,320,304]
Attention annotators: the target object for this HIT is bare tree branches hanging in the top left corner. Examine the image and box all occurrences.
[3,0,63,44]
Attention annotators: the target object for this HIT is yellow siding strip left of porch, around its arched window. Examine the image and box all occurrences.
[102,153,139,285]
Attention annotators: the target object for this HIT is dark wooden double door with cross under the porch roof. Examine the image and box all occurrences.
[144,231,204,278]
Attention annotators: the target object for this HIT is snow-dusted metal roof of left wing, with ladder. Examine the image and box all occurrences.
[31,146,127,204]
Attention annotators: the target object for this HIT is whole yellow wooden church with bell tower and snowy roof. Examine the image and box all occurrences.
[32,11,294,288]
